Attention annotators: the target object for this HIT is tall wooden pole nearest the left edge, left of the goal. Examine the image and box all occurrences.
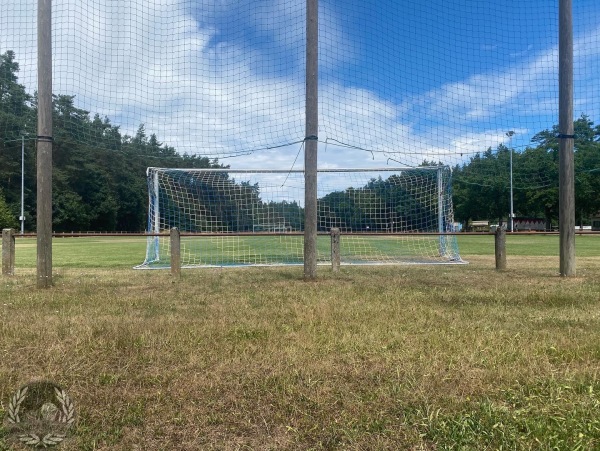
[37,0,52,288]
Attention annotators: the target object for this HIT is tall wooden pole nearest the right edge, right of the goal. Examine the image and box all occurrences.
[558,0,575,276]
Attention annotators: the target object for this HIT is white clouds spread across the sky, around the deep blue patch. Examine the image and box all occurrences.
[0,0,600,173]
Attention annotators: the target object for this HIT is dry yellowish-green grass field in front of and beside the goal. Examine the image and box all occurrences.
[0,235,600,450]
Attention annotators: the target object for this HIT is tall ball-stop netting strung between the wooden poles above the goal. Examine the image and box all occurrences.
[0,0,600,237]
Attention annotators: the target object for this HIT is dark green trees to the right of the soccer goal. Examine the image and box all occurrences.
[453,114,600,230]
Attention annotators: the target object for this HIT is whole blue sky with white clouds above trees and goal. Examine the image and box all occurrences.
[0,0,600,173]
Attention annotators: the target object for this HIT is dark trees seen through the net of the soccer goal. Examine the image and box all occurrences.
[157,166,442,233]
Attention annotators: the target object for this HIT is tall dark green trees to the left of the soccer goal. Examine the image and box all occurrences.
[0,51,221,232]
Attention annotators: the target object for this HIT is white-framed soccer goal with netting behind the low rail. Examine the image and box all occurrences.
[136,166,463,268]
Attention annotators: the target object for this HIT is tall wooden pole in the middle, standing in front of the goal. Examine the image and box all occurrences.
[304,0,319,279]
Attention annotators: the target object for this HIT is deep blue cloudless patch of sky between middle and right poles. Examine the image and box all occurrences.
[325,0,557,96]
